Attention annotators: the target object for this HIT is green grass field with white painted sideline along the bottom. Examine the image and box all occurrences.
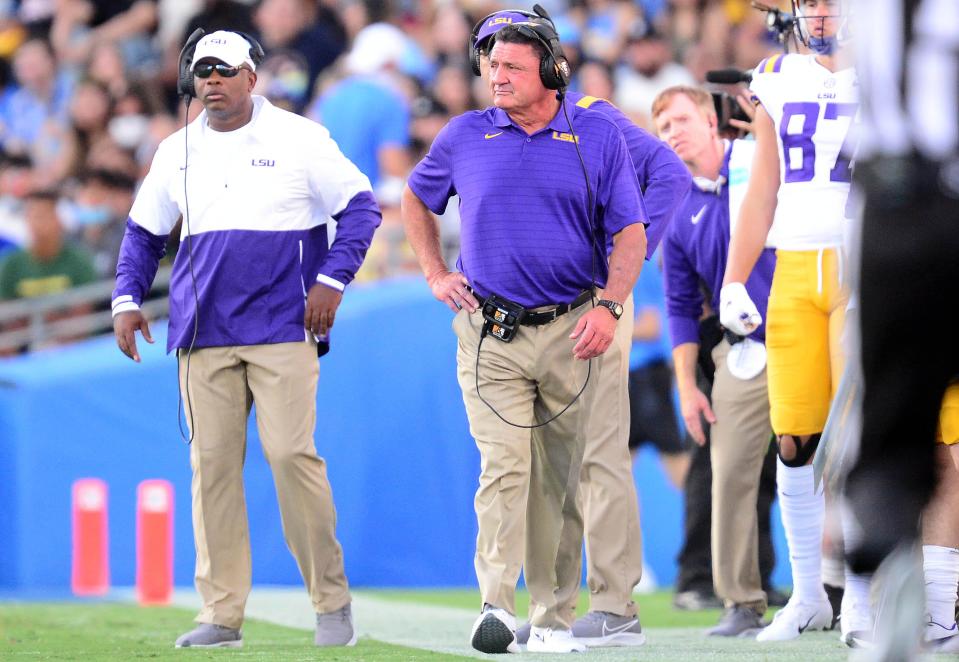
[0,588,848,662]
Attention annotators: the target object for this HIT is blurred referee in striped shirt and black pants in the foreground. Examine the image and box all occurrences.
[846,0,959,572]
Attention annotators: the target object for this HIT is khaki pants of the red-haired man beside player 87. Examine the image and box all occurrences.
[710,339,772,613]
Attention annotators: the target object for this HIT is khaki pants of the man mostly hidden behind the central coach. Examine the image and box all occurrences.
[527,296,643,622]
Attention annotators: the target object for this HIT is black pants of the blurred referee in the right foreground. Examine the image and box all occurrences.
[846,158,959,573]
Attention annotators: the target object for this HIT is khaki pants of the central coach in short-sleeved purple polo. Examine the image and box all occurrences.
[453,304,599,628]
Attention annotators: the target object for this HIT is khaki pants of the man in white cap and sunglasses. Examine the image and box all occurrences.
[179,342,350,628]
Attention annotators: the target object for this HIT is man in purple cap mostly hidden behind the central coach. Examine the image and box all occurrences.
[469,5,688,647]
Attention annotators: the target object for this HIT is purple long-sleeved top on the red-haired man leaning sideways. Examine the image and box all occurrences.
[663,141,776,347]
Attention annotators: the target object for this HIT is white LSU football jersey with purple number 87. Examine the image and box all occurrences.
[750,55,859,250]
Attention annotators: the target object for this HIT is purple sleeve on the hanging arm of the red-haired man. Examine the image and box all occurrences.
[663,205,703,347]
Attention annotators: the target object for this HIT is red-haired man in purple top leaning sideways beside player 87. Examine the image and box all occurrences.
[652,87,776,636]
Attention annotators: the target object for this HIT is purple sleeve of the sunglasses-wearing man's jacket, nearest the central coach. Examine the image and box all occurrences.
[320,191,383,285]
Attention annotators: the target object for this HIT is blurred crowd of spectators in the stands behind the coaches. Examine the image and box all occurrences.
[0,0,788,342]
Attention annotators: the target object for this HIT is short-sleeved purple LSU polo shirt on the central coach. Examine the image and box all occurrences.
[408,102,648,307]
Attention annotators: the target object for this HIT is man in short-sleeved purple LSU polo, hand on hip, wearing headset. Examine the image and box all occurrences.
[403,23,647,653]
